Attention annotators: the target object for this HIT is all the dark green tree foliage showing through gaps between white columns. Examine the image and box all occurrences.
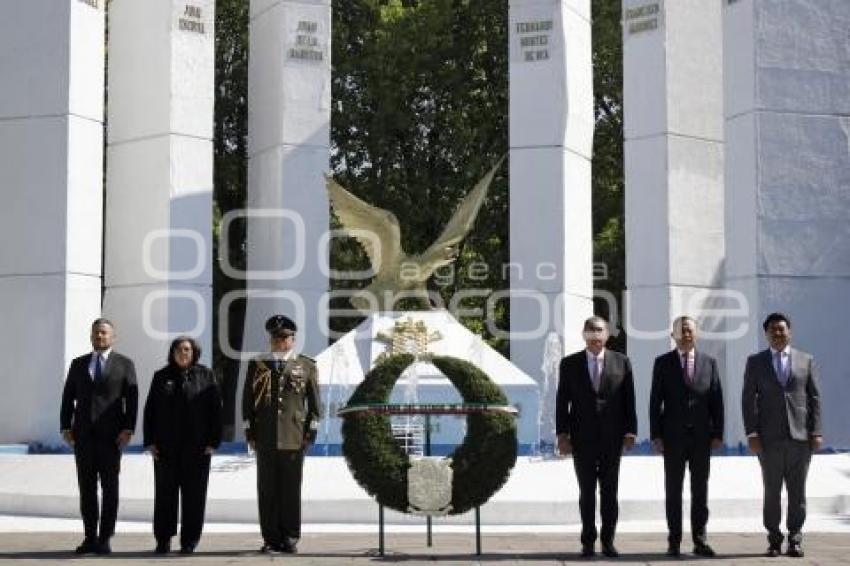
[214,0,625,430]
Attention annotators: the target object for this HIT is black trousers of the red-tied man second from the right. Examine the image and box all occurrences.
[664,433,711,545]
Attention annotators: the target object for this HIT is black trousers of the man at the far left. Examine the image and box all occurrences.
[74,436,121,542]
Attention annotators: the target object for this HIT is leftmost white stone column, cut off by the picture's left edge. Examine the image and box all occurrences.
[0,0,104,444]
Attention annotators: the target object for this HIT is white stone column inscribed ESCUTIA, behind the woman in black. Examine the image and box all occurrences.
[104,0,215,426]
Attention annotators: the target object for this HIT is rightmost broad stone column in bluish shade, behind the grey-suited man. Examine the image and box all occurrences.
[723,0,850,448]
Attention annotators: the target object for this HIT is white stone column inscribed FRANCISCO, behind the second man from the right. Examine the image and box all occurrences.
[623,0,724,444]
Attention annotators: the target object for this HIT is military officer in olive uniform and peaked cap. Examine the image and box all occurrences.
[242,315,319,554]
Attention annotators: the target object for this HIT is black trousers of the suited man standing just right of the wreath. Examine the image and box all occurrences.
[573,446,622,546]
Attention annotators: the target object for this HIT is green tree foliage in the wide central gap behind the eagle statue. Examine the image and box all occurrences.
[331,0,509,350]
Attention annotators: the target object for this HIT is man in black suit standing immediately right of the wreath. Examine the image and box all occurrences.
[555,316,637,558]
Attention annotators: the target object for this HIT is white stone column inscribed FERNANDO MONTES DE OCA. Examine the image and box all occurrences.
[509,0,593,441]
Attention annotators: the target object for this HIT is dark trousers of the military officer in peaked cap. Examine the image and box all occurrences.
[257,450,304,544]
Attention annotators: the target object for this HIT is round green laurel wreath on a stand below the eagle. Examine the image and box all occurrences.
[342,354,517,515]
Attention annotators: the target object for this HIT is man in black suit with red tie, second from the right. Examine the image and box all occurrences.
[649,316,723,557]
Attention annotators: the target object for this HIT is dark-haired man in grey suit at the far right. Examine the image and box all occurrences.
[741,313,823,558]
